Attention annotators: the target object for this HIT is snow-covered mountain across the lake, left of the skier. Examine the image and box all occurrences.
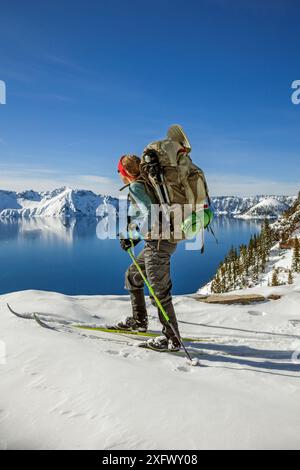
[0,187,117,218]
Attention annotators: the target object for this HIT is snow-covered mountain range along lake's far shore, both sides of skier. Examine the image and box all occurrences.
[0,187,296,218]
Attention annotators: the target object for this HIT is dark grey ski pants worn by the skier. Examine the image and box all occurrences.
[125,240,179,338]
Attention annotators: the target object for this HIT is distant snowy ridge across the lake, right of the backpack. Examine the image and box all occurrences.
[211,196,296,218]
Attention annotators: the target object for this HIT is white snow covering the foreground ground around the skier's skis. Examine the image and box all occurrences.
[0,276,300,450]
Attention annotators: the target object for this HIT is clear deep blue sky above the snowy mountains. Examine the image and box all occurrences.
[0,0,300,195]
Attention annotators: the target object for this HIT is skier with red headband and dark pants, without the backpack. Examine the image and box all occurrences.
[117,155,180,351]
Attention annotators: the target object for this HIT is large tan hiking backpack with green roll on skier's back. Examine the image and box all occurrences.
[140,124,213,253]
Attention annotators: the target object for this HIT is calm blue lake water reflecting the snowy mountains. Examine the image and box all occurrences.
[0,217,260,295]
